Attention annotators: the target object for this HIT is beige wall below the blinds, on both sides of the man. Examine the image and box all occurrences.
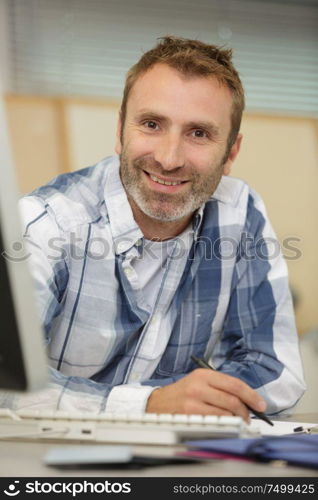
[7,96,318,333]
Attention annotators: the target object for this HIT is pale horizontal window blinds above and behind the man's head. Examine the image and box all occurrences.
[6,0,318,116]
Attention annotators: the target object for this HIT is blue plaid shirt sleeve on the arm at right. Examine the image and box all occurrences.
[215,194,305,414]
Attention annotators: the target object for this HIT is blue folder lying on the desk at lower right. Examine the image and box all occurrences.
[186,434,318,469]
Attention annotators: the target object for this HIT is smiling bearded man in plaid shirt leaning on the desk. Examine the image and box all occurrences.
[6,37,303,420]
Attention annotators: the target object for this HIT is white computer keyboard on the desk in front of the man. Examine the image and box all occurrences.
[0,409,257,445]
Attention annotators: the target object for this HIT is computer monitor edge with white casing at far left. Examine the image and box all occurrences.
[0,95,47,392]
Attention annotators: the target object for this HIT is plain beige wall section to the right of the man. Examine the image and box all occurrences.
[232,115,318,332]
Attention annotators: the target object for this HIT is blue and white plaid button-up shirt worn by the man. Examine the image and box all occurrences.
[6,156,304,413]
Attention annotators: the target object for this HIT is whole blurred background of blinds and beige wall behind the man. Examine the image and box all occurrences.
[0,0,318,410]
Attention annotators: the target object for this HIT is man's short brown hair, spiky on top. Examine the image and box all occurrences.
[121,35,244,153]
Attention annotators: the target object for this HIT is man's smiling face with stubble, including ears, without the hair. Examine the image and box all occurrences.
[116,64,241,221]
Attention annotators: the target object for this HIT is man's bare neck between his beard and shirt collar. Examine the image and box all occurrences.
[128,197,193,241]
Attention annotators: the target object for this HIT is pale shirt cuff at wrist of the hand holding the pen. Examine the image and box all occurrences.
[106,384,157,413]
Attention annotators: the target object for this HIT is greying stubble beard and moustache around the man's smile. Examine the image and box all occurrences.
[120,148,224,222]
